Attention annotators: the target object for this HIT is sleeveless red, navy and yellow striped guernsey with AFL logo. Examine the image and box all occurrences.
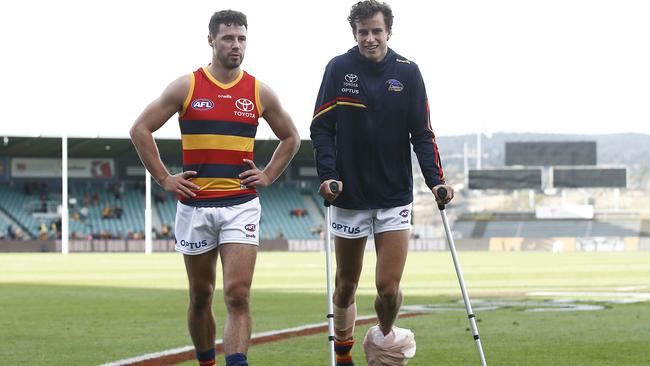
[178,67,263,207]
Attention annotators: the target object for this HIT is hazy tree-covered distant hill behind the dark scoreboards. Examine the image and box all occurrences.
[430,133,650,189]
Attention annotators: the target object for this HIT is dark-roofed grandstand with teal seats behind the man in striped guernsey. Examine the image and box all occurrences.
[0,137,324,251]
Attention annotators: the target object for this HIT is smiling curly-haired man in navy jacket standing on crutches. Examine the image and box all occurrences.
[311,0,453,366]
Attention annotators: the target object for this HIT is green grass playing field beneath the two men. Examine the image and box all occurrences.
[0,252,650,366]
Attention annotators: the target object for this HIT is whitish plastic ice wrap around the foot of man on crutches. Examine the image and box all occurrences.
[363,325,415,366]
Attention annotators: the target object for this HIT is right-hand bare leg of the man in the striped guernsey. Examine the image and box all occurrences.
[219,244,257,355]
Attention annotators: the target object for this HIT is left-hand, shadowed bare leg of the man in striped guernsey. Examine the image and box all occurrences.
[184,249,218,352]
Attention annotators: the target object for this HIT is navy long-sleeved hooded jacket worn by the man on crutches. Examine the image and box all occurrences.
[311,47,445,210]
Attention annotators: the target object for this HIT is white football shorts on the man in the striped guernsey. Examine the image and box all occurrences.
[175,198,262,255]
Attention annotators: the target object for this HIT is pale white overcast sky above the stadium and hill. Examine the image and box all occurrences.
[0,0,650,138]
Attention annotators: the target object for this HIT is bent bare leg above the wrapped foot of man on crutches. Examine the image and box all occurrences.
[375,230,409,335]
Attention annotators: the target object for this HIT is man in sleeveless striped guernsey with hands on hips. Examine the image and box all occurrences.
[131,10,300,366]
